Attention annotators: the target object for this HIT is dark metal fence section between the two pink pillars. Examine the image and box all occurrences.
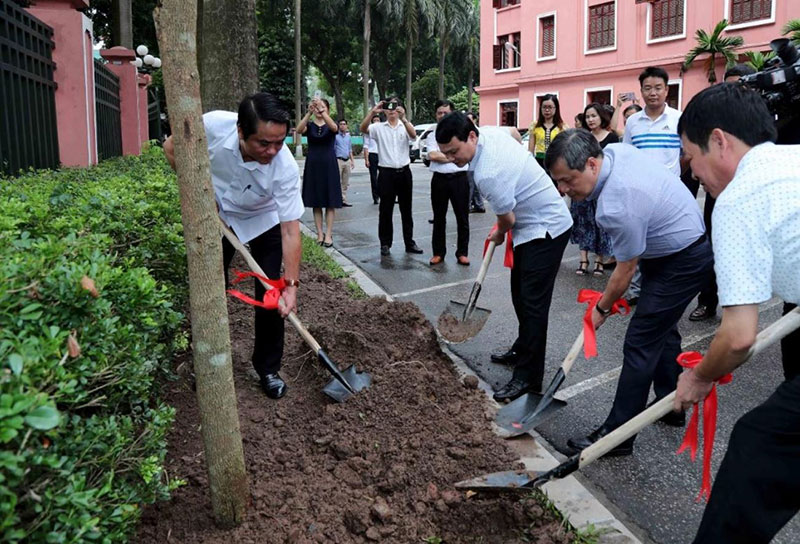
[94,60,122,161]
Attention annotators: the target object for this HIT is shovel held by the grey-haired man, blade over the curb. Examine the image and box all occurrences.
[495,329,583,438]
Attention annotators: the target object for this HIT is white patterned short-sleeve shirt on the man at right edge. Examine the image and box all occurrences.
[711,143,800,306]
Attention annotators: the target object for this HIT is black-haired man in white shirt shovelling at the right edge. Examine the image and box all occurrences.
[675,83,800,544]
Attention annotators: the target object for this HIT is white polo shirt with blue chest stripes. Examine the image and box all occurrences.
[622,105,681,176]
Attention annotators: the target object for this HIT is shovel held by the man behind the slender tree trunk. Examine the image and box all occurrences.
[220,219,372,402]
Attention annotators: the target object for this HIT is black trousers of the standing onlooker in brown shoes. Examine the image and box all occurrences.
[431,172,469,257]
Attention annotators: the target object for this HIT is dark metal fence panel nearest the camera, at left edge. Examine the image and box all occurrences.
[0,0,59,175]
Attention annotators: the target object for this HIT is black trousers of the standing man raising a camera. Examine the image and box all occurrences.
[378,166,414,247]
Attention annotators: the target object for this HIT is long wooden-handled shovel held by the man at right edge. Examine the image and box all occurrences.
[455,308,800,493]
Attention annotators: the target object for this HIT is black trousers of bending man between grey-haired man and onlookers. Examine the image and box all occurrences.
[511,229,571,389]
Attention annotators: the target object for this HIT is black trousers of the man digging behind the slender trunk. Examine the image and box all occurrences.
[222,225,284,377]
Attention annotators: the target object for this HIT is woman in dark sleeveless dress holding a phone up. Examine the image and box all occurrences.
[297,98,342,247]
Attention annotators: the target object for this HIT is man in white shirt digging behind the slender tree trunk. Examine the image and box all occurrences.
[164,93,304,399]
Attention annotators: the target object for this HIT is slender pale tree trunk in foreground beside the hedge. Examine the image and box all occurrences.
[154,0,250,528]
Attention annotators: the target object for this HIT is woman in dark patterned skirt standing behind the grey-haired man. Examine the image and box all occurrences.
[570,102,619,276]
